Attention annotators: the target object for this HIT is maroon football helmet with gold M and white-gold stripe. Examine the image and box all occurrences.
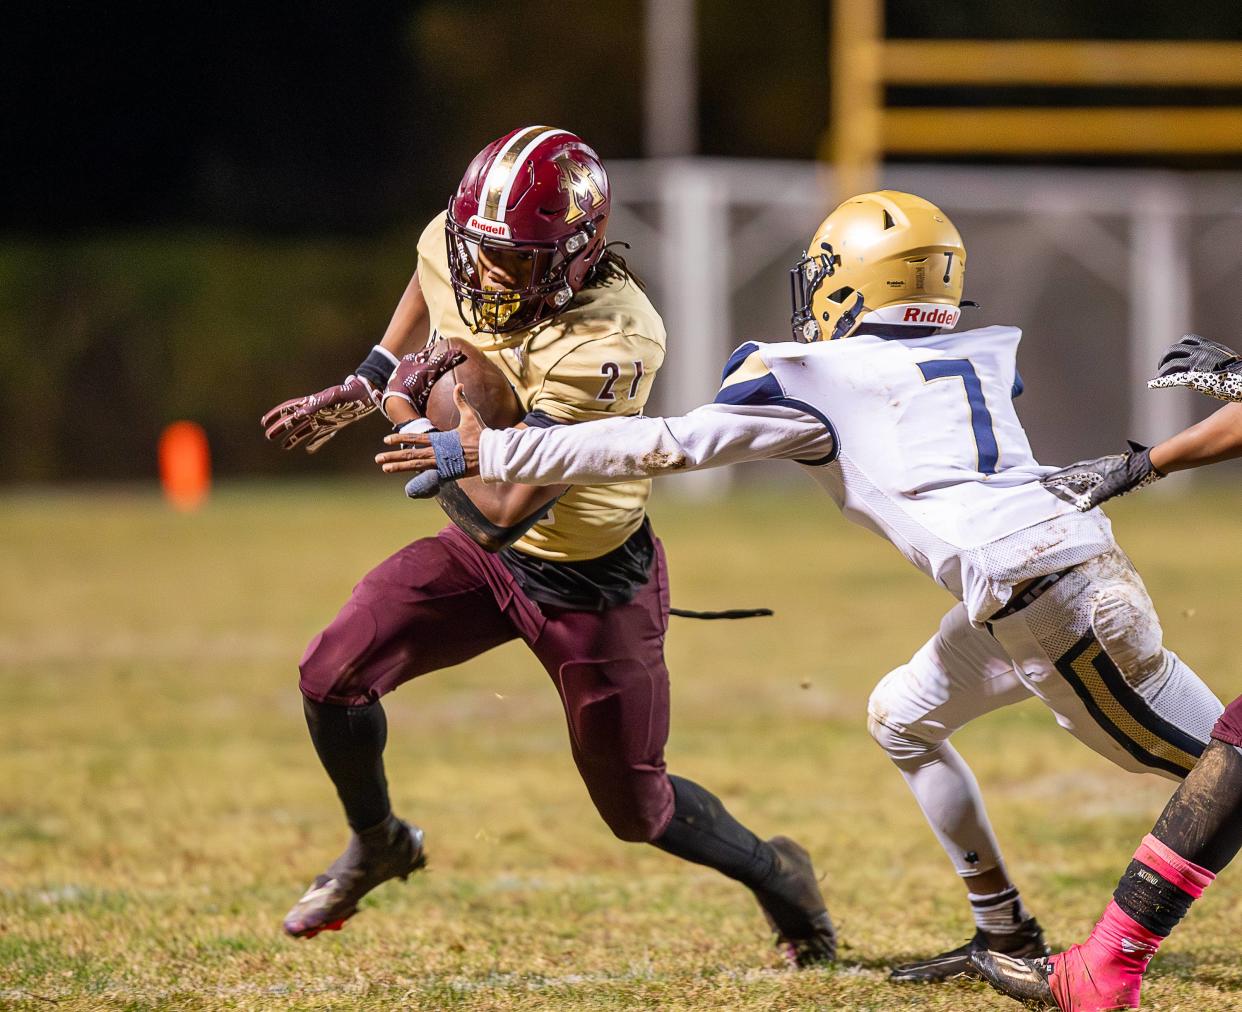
[445,127,612,334]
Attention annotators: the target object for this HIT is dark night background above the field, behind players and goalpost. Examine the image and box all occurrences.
[0,0,1242,481]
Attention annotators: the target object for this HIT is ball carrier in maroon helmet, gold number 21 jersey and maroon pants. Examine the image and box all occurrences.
[265,127,836,965]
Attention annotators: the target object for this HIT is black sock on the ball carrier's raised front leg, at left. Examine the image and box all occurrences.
[302,697,392,833]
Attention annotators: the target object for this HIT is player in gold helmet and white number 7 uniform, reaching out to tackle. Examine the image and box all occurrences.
[376,190,1222,981]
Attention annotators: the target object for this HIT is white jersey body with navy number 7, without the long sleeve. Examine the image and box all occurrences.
[717,327,1113,621]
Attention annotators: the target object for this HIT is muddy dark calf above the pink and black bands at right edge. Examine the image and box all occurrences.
[1147,740,1242,874]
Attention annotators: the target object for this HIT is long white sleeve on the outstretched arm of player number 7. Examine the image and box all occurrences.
[478,404,833,484]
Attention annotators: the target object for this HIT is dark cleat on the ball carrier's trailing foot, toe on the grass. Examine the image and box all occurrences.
[753,837,837,967]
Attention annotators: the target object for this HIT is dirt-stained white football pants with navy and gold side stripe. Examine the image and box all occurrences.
[867,548,1223,878]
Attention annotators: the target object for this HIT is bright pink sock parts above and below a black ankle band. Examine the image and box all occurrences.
[1051,834,1216,1012]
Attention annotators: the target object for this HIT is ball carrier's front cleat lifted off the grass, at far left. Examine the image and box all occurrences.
[283,815,427,939]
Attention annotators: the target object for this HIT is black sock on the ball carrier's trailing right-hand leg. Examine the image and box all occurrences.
[652,776,776,889]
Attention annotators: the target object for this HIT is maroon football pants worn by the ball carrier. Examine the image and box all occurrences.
[301,526,673,842]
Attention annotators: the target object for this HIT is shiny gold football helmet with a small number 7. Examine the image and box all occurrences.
[789,190,966,343]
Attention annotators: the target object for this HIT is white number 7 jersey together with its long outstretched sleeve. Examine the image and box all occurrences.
[478,327,1114,622]
